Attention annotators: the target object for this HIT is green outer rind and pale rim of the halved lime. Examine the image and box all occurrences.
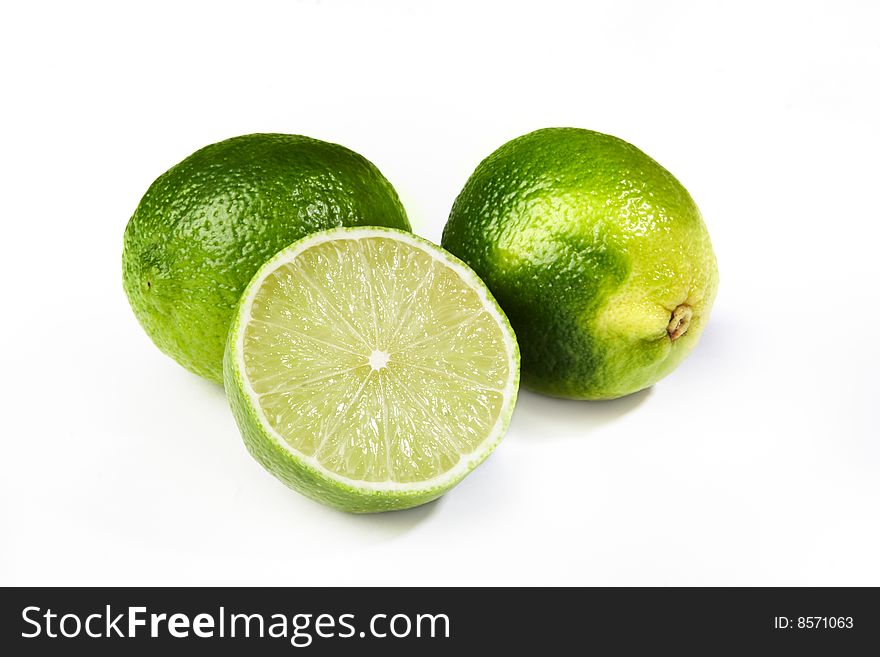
[223,227,520,513]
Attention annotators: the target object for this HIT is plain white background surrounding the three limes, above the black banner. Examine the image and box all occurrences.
[0,0,880,585]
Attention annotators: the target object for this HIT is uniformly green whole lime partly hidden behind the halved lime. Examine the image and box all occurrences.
[122,134,410,382]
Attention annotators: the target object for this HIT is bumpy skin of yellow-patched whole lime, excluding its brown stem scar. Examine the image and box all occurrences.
[442,128,718,399]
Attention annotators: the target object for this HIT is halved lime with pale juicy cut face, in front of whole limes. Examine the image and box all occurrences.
[224,228,519,512]
